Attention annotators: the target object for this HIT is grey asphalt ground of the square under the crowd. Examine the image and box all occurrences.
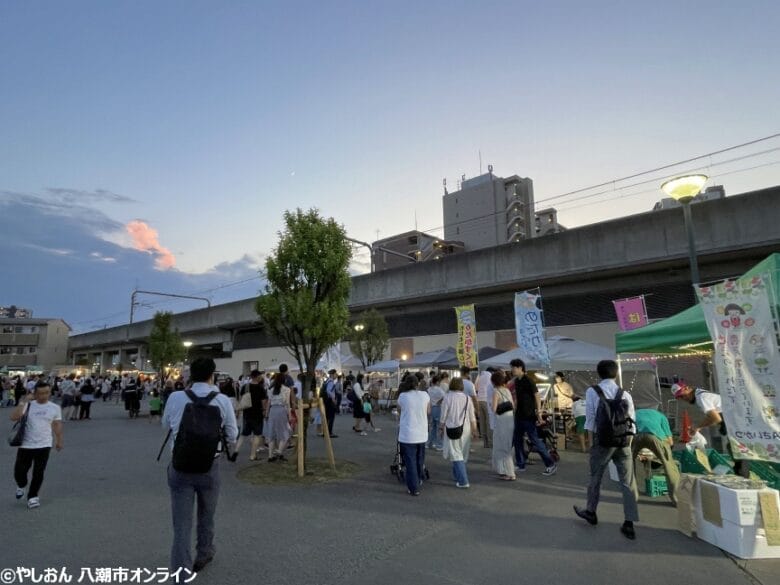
[0,402,780,585]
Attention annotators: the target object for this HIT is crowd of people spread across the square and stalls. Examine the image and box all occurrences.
[10,358,722,571]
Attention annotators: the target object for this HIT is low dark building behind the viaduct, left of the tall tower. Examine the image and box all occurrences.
[371,230,464,271]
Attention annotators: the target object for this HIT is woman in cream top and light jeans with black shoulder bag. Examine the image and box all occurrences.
[439,378,477,488]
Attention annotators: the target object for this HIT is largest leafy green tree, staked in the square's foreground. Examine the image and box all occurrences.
[255,209,352,460]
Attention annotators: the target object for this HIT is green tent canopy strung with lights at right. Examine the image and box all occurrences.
[615,253,780,354]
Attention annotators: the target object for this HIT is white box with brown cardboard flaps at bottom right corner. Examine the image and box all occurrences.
[693,479,780,559]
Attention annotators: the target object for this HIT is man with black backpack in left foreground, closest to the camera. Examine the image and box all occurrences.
[162,358,238,572]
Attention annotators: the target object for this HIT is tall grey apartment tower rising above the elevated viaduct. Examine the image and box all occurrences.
[443,166,536,251]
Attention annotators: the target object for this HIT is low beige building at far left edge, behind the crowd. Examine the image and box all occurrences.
[0,318,70,371]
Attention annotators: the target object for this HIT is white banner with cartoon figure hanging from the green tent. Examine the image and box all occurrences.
[696,276,780,461]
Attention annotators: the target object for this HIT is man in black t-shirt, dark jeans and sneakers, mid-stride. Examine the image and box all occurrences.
[509,359,558,475]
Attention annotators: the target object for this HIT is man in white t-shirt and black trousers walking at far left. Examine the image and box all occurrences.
[11,380,62,509]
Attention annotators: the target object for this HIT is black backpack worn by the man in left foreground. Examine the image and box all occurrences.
[172,390,222,473]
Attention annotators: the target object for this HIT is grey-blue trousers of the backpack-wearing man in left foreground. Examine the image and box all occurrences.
[168,459,220,571]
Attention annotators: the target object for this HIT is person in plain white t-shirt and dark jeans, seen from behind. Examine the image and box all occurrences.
[398,375,431,496]
